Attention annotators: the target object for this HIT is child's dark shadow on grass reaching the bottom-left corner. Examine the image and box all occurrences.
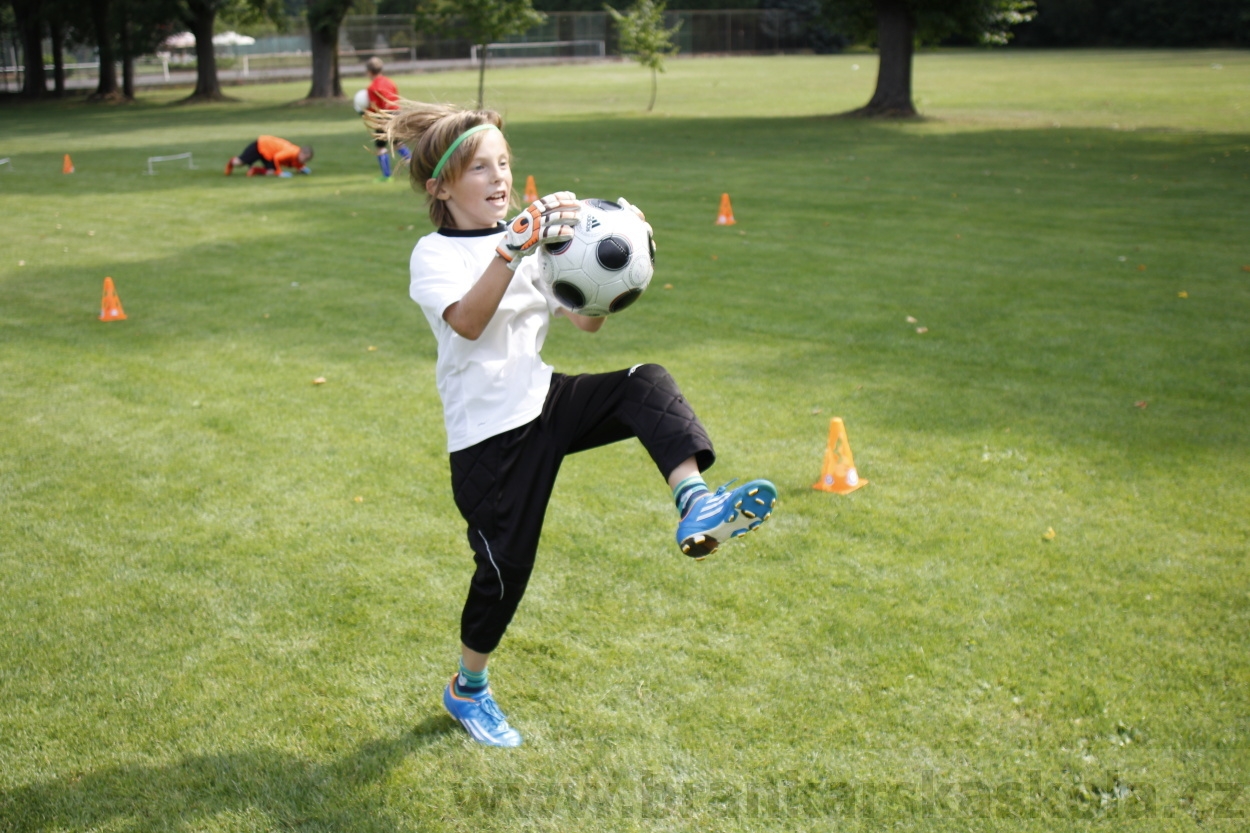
[0,714,458,830]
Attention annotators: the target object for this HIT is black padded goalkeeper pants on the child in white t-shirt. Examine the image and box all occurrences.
[451,364,716,654]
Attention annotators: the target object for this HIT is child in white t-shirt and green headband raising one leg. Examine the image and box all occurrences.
[373,101,776,747]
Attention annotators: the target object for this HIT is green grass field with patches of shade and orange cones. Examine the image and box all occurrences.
[0,53,1250,833]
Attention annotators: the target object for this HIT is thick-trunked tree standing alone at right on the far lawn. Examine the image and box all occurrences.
[829,0,1034,118]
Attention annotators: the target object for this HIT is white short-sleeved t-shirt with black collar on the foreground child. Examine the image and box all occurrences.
[409,228,560,452]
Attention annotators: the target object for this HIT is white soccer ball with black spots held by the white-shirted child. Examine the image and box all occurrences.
[538,199,655,318]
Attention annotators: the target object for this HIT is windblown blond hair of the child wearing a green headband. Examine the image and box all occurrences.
[365,99,516,229]
